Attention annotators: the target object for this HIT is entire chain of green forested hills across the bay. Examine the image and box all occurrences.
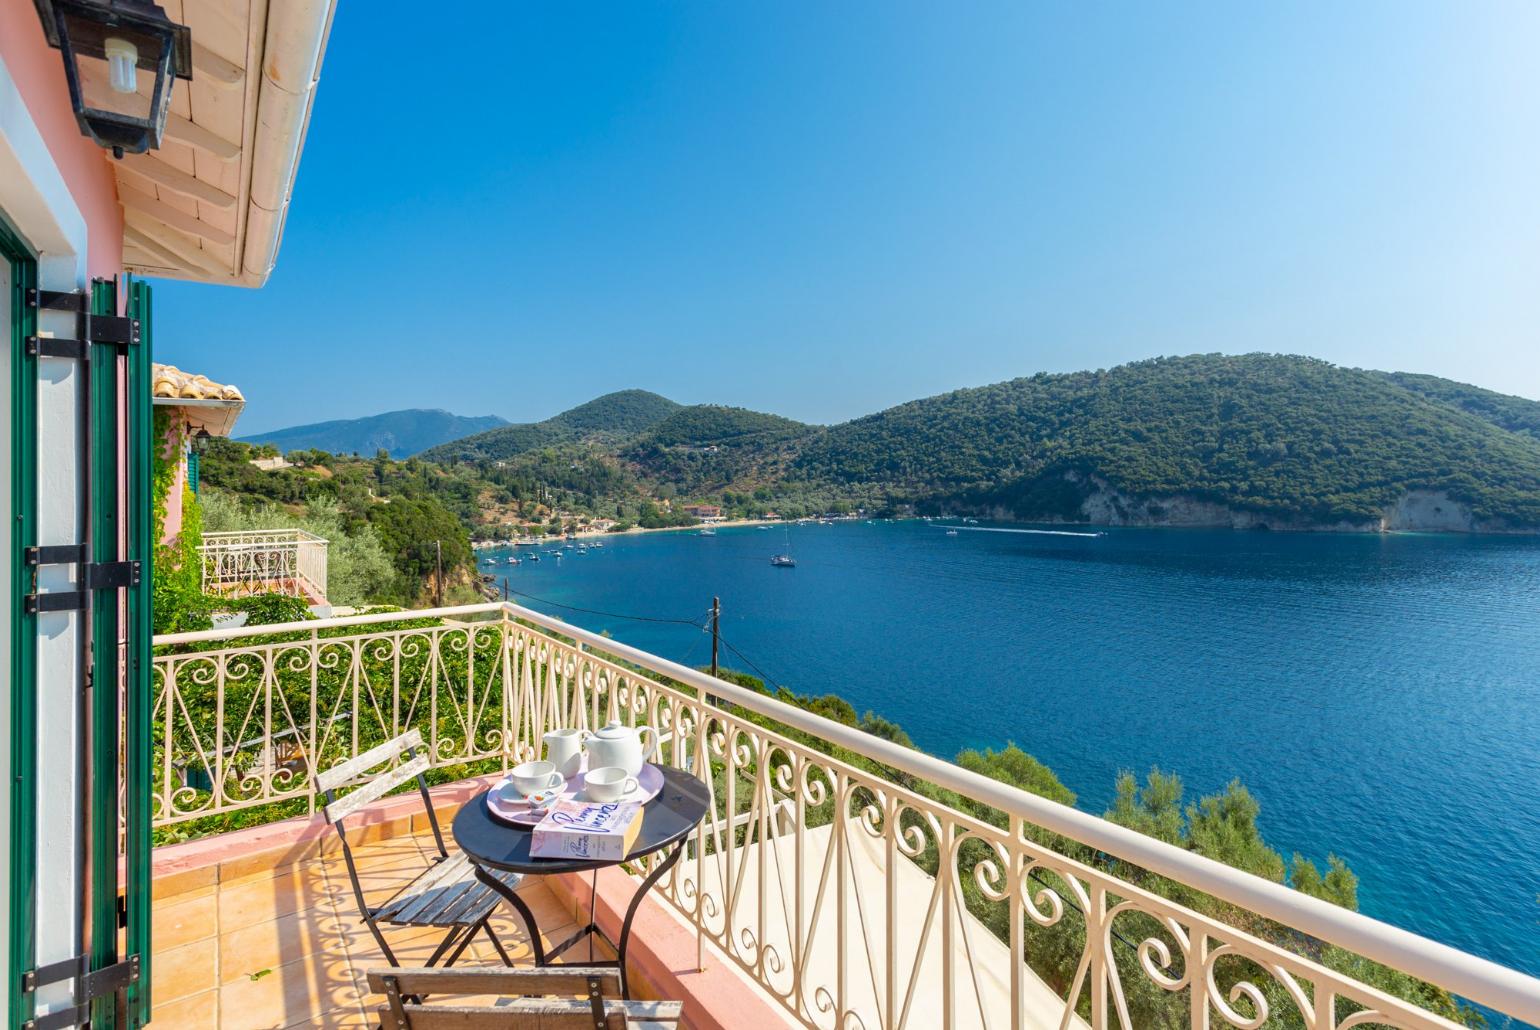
[403,354,1540,531]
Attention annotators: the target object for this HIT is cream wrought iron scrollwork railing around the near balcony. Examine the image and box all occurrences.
[154,604,1540,1030]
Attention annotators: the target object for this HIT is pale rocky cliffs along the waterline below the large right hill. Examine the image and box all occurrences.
[993,473,1534,533]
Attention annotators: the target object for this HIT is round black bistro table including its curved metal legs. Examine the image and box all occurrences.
[453,765,710,998]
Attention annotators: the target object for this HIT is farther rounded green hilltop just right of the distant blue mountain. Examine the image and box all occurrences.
[424,390,681,462]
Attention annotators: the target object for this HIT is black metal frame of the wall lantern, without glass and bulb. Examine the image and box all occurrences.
[34,0,193,157]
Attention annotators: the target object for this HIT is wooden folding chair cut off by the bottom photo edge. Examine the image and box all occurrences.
[368,965,684,1030]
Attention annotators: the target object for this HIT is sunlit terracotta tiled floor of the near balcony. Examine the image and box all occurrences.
[151,834,581,1030]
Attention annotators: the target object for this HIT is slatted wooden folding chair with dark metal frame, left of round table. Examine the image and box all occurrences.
[316,730,521,965]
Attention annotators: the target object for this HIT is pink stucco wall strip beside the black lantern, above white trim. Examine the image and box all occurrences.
[0,0,123,276]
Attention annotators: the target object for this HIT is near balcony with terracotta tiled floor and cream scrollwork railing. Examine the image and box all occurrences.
[152,604,1540,1030]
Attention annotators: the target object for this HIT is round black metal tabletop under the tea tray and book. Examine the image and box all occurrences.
[453,765,710,876]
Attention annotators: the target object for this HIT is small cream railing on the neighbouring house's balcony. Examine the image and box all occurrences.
[199,530,326,602]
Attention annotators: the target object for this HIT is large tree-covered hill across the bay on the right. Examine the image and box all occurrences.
[795,354,1540,528]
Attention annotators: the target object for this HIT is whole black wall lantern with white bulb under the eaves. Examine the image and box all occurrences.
[34,0,193,157]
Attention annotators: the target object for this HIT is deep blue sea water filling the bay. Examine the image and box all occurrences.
[482,522,1540,975]
